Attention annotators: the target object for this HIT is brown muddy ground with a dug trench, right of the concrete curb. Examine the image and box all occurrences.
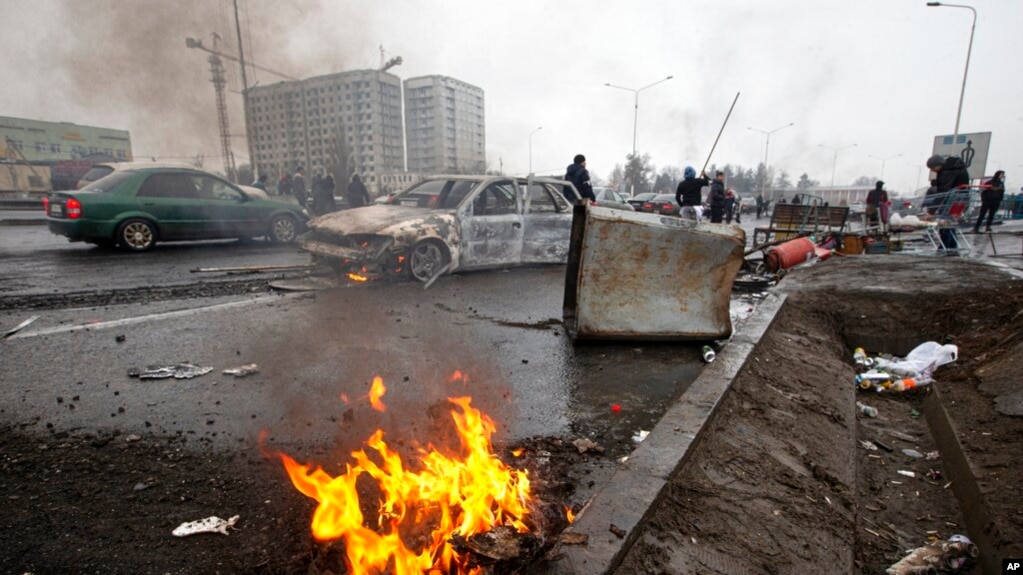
[618,258,1023,575]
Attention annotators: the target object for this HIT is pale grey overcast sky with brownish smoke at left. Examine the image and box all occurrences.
[0,0,1023,190]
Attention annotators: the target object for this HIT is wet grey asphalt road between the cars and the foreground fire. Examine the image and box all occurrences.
[0,228,701,454]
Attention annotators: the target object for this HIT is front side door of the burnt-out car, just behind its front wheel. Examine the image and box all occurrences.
[458,179,523,269]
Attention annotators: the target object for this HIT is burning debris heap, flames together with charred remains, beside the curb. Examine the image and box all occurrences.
[278,378,572,575]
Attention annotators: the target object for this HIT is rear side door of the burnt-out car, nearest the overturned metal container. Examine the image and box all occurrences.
[520,180,572,264]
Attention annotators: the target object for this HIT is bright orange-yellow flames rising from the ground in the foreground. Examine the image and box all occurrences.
[279,388,530,575]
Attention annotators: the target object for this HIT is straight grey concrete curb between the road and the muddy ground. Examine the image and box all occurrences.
[546,292,788,575]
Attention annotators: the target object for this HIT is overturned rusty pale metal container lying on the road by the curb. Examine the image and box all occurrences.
[564,205,746,341]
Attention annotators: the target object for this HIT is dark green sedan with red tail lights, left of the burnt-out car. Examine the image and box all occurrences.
[44,163,309,252]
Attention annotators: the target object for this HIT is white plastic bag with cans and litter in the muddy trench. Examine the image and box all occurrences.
[852,342,959,393]
